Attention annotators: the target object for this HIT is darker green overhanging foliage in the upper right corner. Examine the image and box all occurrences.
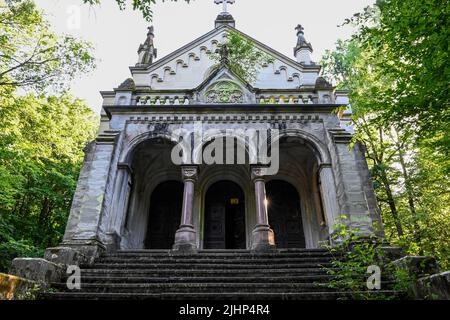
[347,0,450,174]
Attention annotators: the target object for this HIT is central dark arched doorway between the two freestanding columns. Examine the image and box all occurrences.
[203,181,246,249]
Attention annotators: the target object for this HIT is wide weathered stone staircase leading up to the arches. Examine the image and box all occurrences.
[44,249,402,300]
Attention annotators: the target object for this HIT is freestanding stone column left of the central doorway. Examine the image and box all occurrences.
[173,166,198,252]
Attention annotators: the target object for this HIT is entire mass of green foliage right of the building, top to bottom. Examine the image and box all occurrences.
[324,0,450,269]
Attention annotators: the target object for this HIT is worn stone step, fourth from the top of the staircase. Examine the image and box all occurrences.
[81,268,327,277]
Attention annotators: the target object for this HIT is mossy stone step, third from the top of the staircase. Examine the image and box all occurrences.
[81,261,332,270]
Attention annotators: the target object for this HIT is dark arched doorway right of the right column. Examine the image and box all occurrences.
[266,180,305,248]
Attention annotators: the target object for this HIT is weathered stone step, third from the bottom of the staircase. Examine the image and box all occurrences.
[69,274,331,283]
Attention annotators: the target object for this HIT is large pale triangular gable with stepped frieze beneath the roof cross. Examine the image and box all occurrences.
[131,26,320,90]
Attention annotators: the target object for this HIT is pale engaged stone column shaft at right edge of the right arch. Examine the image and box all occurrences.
[319,164,339,235]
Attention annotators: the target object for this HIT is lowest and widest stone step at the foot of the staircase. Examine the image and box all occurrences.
[41,290,405,301]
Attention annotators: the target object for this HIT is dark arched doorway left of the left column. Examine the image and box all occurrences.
[145,181,183,249]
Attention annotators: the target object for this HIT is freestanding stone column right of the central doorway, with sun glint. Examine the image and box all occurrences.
[251,167,275,251]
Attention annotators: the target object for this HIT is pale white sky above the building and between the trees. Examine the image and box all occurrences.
[35,0,375,112]
